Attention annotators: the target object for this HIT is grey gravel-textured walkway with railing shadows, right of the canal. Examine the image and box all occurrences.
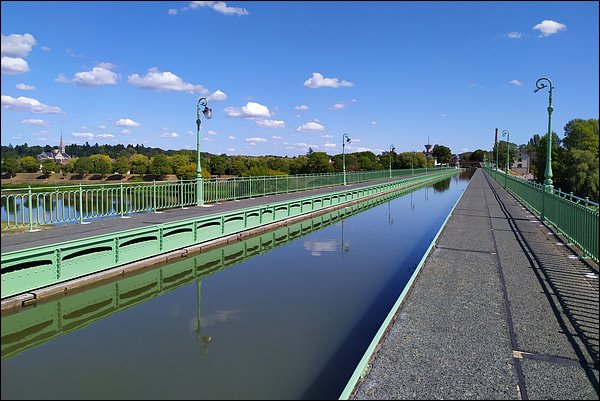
[350,169,599,400]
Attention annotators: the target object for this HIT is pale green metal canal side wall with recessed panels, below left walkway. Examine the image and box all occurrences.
[0,169,462,298]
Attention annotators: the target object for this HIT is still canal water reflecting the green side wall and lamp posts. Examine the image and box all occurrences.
[1,171,472,399]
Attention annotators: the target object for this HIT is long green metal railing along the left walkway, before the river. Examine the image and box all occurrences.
[0,168,450,231]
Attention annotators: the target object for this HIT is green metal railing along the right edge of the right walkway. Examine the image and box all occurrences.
[485,167,600,262]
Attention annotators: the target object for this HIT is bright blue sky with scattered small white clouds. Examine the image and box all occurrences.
[1,1,599,156]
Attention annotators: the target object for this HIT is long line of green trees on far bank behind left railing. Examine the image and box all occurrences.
[2,142,452,180]
